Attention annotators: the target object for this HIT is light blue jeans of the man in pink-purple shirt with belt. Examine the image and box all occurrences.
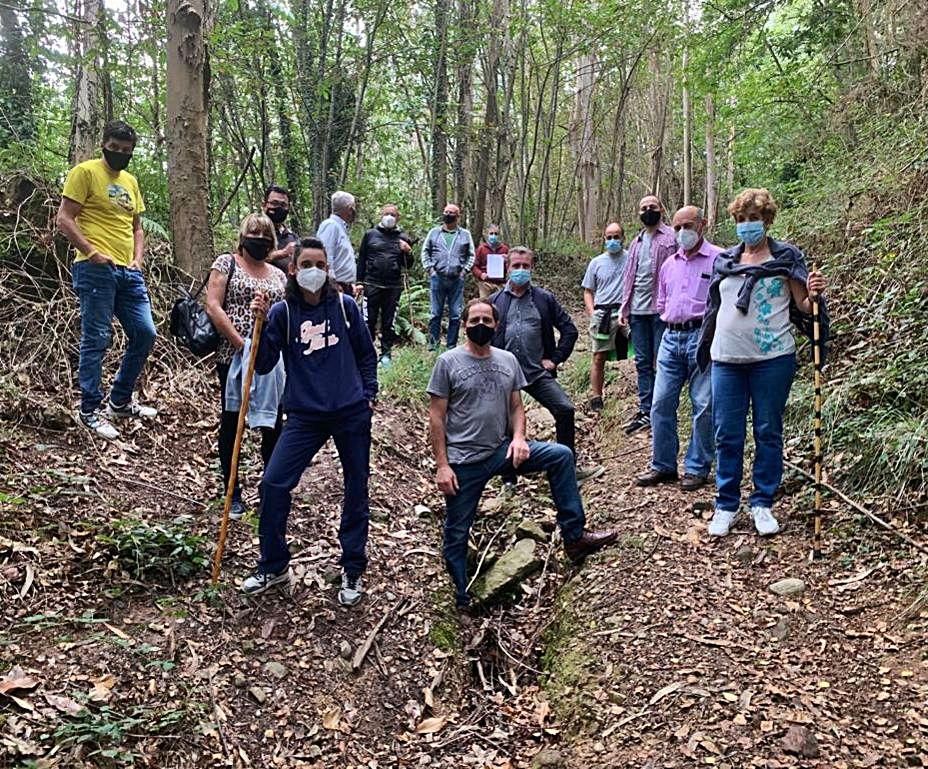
[651,328,715,477]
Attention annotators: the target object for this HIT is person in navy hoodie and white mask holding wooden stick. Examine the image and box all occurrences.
[242,238,377,606]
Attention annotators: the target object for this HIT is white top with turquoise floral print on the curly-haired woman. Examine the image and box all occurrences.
[709,275,796,363]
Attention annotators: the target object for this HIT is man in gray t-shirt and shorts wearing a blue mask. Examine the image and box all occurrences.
[581,222,628,412]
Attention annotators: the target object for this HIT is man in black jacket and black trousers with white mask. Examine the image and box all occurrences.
[358,204,412,368]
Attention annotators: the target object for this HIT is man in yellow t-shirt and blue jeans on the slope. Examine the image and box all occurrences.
[57,120,158,440]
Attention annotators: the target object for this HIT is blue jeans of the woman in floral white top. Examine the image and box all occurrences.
[712,353,796,512]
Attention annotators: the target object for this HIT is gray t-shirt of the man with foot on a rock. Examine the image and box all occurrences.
[426,346,526,465]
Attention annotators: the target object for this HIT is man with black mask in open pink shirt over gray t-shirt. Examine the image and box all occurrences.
[621,195,677,435]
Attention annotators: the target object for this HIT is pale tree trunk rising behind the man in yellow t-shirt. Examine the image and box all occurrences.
[68,0,112,165]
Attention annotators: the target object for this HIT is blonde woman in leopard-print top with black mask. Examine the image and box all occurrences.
[206,214,286,518]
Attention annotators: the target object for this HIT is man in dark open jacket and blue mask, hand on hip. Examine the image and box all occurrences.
[490,246,603,483]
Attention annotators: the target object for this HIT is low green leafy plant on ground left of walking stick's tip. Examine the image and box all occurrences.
[97,516,208,582]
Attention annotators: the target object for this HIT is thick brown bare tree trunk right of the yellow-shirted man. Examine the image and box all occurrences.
[167,0,213,274]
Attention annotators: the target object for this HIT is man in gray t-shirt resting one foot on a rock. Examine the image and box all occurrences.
[428,299,617,608]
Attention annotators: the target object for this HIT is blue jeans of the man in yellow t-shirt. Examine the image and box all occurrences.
[71,261,157,414]
